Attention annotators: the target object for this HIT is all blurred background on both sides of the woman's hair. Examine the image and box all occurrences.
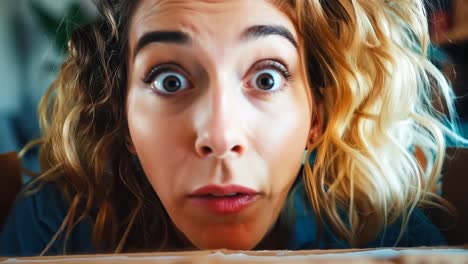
[0,0,468,177]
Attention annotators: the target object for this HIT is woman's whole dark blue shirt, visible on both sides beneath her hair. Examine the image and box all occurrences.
[0,184,446,256]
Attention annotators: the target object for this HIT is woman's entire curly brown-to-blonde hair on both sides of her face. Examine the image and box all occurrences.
[24,0,459,253]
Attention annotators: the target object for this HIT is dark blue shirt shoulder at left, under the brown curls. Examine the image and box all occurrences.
[0,183,91,256]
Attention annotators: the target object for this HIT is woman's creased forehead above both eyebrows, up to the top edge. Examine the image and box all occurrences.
[129,0,297,50]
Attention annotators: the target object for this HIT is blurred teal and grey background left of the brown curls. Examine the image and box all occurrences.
[0,0,97,175]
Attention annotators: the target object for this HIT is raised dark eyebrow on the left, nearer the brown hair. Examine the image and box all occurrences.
[133,30,192,58]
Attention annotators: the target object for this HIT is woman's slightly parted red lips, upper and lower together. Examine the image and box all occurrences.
[188,185,259,214]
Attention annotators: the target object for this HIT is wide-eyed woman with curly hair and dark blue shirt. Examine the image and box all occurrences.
[1,0,456,255]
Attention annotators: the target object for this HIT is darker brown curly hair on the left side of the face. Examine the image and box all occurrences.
[26,1,175,253]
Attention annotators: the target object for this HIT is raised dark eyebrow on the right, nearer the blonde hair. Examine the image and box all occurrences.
[241,25,298,49]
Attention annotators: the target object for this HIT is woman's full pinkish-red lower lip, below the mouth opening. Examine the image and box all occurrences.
[190,194,258,214]
